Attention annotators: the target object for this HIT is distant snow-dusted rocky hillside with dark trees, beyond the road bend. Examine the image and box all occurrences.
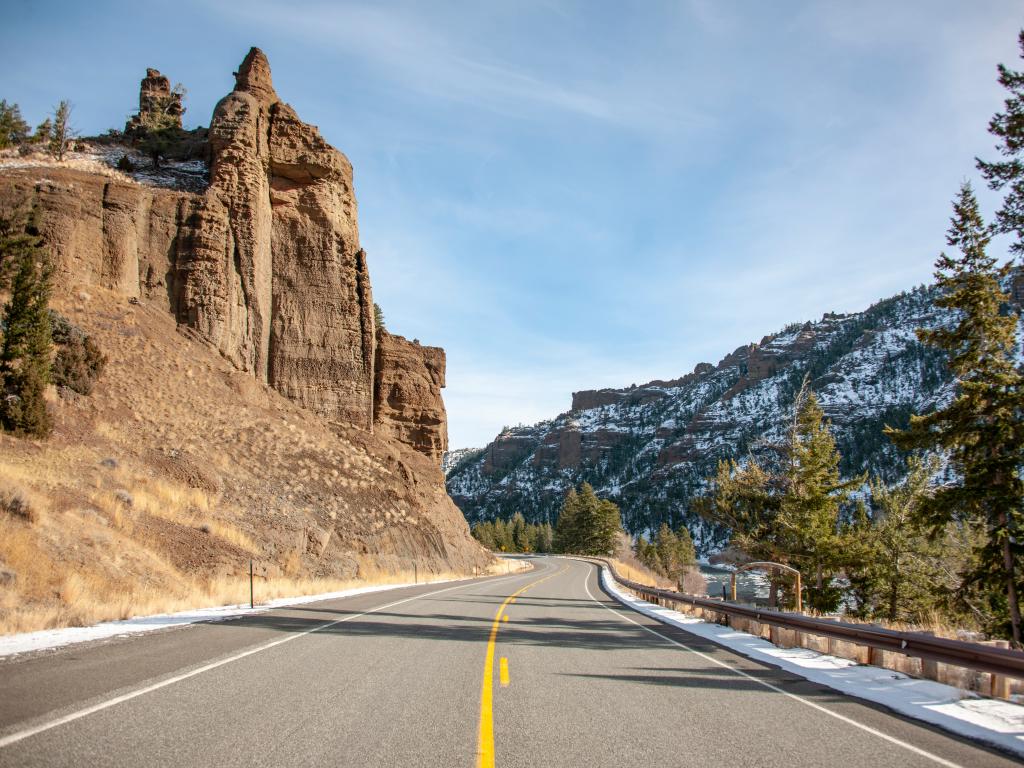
[447,282,1022,555]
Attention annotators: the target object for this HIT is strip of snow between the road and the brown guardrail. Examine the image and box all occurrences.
[601,565,1024,757]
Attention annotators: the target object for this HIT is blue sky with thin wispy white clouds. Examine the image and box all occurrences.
[0,0,1024,447]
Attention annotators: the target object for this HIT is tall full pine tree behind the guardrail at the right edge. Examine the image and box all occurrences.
[887,183,1024,647]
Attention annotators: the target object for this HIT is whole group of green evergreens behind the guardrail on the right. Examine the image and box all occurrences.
[697,32,1024,647]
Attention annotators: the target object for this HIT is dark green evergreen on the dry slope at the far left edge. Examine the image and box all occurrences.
[0,214,52,437]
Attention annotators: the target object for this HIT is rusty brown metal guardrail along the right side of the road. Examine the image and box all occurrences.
[581,558,1024,680]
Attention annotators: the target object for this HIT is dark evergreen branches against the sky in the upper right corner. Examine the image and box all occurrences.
[977,31,1024,255]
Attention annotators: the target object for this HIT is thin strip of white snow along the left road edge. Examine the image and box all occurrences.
[0,579,459,658]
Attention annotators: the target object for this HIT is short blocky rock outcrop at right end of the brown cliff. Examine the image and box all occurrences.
[374,330,447,467]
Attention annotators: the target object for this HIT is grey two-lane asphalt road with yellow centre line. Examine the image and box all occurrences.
[0,558,1019,768]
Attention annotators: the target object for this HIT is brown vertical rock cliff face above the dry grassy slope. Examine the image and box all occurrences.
[0,48,447,466]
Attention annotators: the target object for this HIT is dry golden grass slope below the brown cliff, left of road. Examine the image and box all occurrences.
[0,285,487,634]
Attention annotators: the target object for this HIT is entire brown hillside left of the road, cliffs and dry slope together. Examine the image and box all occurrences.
[0,48,488,638]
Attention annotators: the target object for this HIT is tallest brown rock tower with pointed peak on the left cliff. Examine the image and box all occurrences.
[190,48,374,429]
